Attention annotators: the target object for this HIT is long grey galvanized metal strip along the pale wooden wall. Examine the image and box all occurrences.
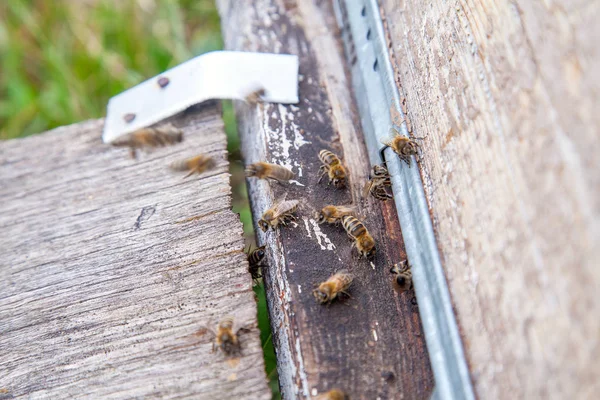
[334,0,475,400]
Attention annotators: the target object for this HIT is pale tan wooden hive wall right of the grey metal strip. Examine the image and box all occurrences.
[381,0,600,399]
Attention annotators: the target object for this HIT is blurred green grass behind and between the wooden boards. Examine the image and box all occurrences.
[0,0,280,399]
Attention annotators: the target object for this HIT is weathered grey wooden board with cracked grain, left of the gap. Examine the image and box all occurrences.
[0,104,270,399]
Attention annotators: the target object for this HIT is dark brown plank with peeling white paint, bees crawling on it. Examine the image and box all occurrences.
[217,0,433,400]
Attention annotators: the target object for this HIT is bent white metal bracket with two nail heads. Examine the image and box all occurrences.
[102,51,298,143]
